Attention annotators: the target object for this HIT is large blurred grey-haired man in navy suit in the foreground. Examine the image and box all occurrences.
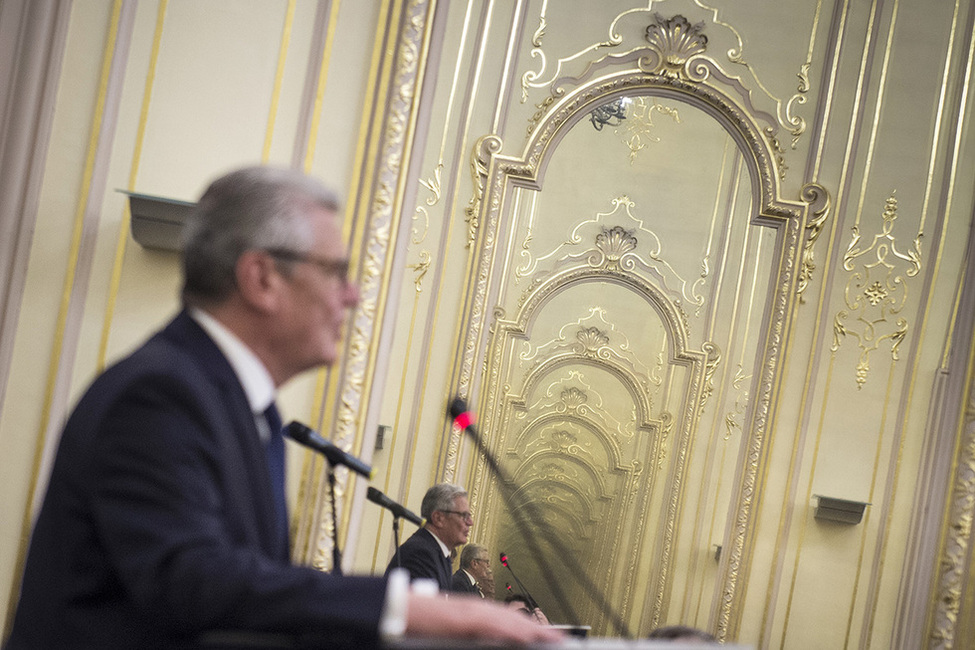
[7,167,564,650]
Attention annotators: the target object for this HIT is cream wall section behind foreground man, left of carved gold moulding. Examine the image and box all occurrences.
[0,0,381,628]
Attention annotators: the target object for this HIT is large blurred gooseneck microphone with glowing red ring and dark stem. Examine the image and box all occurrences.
[448,397,631,638]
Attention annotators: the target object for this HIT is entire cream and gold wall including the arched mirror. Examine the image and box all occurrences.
[0,0,975,648]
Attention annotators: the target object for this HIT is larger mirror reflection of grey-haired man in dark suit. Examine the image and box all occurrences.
[386,483,474,592]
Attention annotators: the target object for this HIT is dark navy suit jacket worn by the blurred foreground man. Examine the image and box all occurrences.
[8,312,385,649]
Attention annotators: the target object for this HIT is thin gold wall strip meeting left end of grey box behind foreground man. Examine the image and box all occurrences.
[96,0,169,372]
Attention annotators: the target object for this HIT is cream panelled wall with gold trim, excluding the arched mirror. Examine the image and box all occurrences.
[0,0,975,648]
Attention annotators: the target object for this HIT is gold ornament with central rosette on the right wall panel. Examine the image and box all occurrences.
[831,195,921,389]
